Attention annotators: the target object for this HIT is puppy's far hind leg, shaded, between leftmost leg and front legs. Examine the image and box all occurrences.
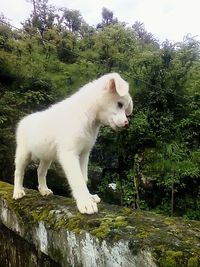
[37,160,53,196]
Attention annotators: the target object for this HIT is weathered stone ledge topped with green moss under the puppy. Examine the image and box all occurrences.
[0,182,200,267]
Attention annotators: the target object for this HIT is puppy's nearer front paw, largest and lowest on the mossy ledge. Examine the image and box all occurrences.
[76,195,98,214]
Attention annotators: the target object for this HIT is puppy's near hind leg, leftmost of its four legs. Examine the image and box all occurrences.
[13,146,31,199]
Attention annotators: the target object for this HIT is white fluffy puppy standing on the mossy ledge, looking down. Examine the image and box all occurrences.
[13,73,133,214]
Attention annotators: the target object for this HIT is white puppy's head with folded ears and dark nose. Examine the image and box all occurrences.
[98,73,133,130]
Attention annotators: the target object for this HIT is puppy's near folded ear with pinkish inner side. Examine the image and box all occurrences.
[107,79,129,96]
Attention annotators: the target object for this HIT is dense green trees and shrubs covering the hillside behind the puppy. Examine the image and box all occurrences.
[0,0,200,219]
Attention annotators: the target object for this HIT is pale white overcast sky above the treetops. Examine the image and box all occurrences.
[0,0,200,42]
